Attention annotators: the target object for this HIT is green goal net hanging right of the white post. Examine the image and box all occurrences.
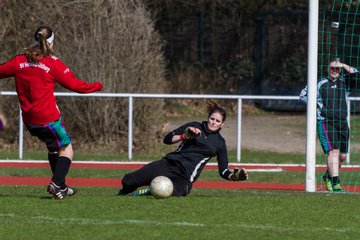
[316,0,360,192]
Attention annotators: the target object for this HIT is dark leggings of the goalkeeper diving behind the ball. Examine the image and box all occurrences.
[121,158,192,196]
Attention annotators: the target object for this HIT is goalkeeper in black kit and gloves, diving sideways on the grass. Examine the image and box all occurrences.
[118,101,248,196]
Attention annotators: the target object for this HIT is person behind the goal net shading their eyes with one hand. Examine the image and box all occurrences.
[300,59,358,192]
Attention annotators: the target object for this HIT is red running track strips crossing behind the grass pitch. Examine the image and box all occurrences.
[0,161,360,192]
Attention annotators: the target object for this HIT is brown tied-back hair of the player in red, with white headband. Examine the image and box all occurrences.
[25,26,53,63]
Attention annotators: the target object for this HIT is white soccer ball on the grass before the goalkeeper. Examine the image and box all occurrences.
[150,176,174,198]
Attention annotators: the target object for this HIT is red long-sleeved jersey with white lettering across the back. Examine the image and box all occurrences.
[0,54,102,125]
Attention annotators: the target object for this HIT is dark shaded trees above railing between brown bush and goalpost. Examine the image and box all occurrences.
[146,0,308,94]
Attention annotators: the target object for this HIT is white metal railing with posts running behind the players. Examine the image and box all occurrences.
[0,91,299,162]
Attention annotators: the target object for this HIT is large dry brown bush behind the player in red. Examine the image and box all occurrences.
[0,0,167,151]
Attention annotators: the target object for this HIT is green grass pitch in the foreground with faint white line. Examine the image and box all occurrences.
[0,183,360,240]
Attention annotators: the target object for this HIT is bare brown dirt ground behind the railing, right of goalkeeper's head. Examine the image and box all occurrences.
[169,114,306,153]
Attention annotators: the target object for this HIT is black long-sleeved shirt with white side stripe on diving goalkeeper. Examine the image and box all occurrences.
[163,121,231,182]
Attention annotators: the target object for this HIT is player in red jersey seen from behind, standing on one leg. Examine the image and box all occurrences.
[0,26,102,200]
